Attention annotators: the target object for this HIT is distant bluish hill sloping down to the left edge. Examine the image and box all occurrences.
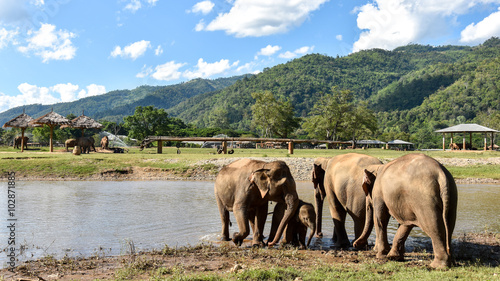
[0,75,246,124]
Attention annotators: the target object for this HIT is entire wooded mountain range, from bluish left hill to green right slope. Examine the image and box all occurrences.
[0,38,500,148]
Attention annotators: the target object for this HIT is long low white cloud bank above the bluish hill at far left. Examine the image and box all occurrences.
[0,83,106,112]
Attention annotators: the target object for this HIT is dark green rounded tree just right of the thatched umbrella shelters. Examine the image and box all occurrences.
[123,106,171,140]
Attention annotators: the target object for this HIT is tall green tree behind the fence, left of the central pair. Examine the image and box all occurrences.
[252,91,300,138]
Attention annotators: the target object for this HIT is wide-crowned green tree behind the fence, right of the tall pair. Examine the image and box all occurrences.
[302,87,354,140]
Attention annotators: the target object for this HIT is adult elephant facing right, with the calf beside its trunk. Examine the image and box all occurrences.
[214,159,299,247]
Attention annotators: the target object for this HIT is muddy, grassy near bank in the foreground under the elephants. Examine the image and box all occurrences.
[0,232,500,281]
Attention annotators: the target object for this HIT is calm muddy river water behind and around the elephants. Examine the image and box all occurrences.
[0,181,500,266]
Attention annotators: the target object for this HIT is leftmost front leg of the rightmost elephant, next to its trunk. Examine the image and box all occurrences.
[373,200,391,259]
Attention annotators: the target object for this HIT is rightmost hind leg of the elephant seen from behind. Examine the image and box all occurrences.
[419,211,451,268]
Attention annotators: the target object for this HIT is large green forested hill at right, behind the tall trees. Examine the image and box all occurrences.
[168,38,500,147]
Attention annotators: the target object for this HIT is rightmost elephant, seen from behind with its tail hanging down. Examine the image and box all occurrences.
[354,154,458,268]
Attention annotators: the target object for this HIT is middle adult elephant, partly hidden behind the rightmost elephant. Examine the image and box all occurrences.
[312,153,382,248]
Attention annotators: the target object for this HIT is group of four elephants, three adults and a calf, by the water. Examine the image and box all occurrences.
[214,153,458,268]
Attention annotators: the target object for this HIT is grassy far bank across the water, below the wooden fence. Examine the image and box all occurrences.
[4,154,500,184]
